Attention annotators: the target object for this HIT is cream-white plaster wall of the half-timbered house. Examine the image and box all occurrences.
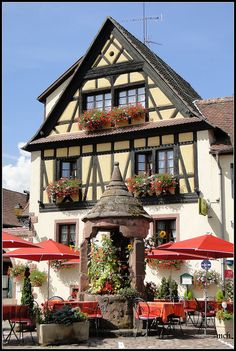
[21,131,234,303]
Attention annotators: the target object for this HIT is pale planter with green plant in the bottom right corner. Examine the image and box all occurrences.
[215,309,234,338]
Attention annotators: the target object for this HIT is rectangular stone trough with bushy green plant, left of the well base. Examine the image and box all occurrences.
[37,305,89,345]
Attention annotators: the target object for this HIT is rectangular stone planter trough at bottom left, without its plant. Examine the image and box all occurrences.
[36,320,89,345]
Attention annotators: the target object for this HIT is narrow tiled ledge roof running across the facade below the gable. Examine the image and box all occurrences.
[27,117,205,145]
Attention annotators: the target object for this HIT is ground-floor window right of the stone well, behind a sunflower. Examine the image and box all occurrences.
[153,219,176,246]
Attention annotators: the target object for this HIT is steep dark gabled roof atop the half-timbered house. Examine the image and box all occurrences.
[23,17,206,151]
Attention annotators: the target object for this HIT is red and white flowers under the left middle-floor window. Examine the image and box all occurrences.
[45,177,82,202]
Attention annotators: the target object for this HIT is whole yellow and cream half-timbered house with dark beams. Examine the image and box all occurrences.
[12,17,233,299]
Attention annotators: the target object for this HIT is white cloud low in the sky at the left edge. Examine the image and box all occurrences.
[2,143,30,193]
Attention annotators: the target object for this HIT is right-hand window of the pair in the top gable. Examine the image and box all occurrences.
[117,87,145,107]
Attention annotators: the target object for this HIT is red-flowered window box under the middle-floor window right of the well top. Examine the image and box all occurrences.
[126,173,178,197]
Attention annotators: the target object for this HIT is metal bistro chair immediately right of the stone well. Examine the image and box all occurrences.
[133,297,161,336]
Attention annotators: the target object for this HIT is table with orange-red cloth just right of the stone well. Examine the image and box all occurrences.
[137,301,185,323]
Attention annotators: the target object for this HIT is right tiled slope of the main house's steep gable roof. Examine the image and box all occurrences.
[109,17,201,113]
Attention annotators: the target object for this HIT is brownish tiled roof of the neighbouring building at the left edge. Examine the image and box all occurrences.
[2,188,29,227]
